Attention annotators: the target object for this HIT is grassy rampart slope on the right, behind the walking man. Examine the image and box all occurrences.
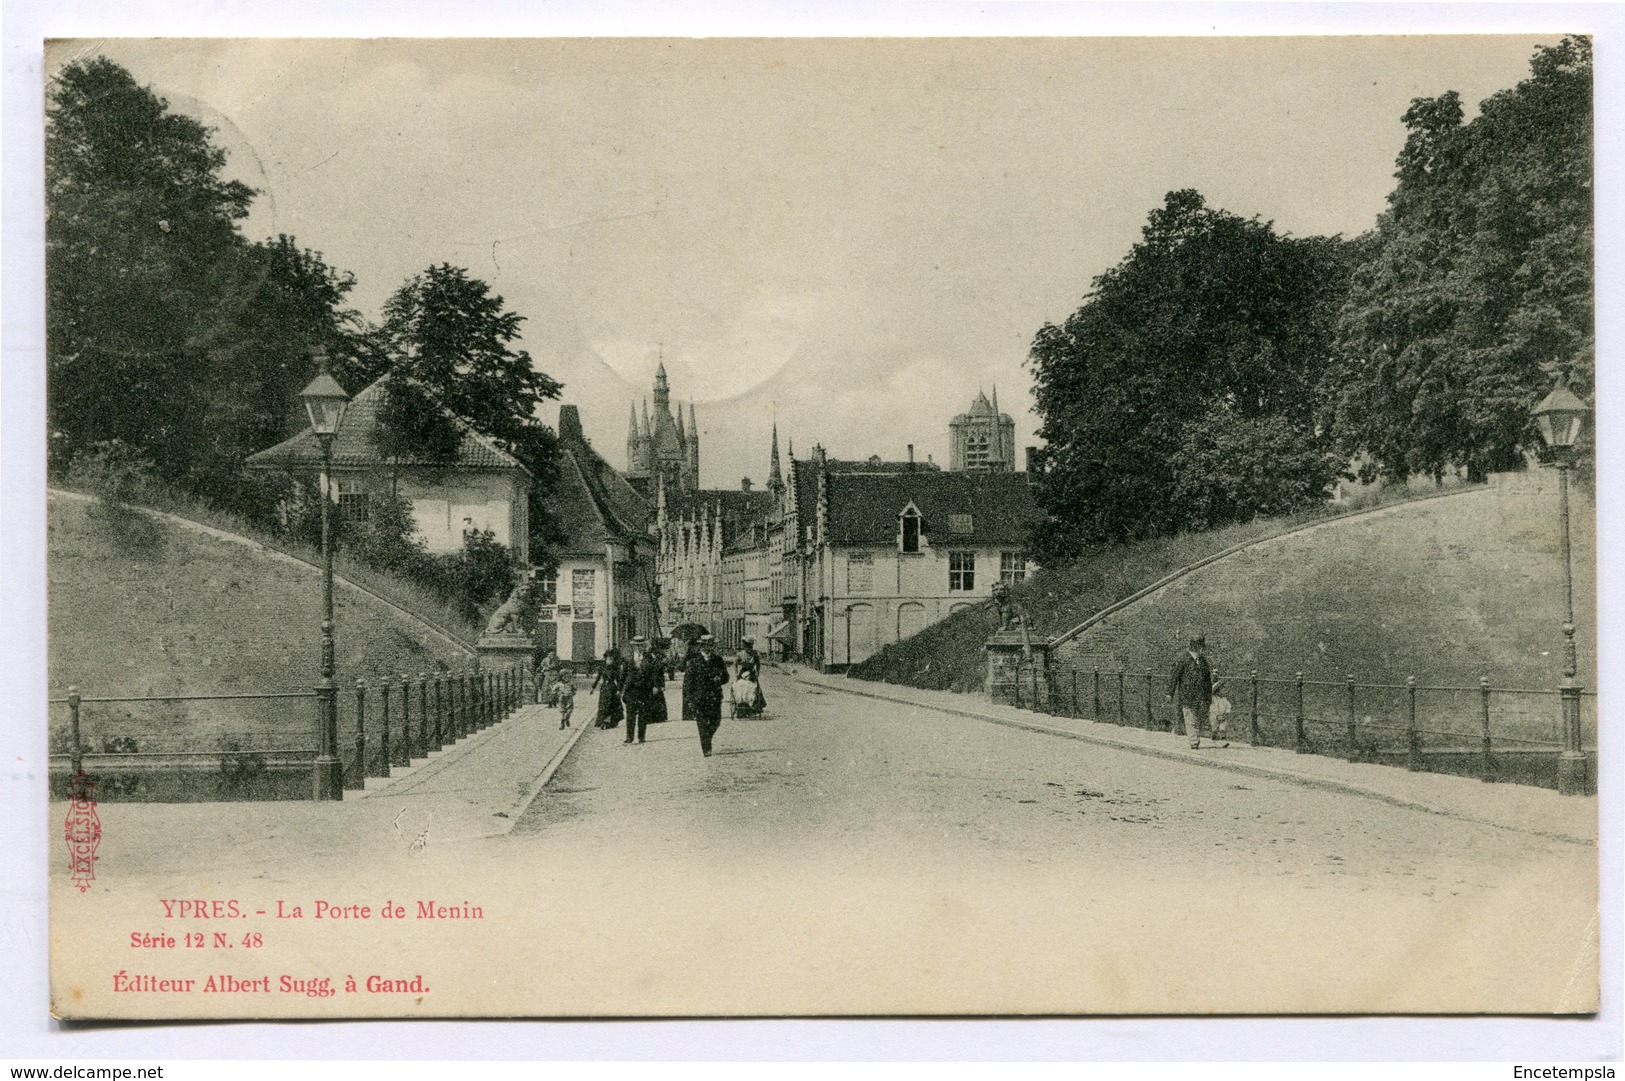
[853,478,1596,711]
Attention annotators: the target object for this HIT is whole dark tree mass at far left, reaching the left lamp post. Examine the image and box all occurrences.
[46,57,359,510]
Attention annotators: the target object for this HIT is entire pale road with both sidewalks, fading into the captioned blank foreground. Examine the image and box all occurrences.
[49,670,1597,1016]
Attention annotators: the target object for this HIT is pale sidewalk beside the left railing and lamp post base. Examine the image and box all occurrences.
[61,695,592,879]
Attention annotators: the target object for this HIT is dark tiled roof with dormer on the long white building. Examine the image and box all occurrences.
[829,470,1042,548]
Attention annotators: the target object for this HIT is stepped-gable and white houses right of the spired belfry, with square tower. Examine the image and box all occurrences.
[655,377,1038,670]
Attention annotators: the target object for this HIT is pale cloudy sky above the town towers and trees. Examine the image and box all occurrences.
[60,34,1557,486]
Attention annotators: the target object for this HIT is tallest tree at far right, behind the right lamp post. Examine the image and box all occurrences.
[1324,37,1596,478]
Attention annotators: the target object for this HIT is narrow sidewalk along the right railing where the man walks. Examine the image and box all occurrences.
[780,663,1597,845]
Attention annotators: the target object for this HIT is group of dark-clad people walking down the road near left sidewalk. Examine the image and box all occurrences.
[536,634,767,758]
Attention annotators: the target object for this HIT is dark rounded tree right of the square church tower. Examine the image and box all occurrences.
[1029,190,1349,559]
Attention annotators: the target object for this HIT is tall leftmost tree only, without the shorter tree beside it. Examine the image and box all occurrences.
[46,57,254,471]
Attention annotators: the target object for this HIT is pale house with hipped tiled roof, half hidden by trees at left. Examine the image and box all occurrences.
[244,377,535,564]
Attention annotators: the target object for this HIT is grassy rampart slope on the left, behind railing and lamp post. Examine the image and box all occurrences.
[47,497,468,751]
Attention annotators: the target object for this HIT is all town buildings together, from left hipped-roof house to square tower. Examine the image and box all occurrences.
[249,366,1038,668]
